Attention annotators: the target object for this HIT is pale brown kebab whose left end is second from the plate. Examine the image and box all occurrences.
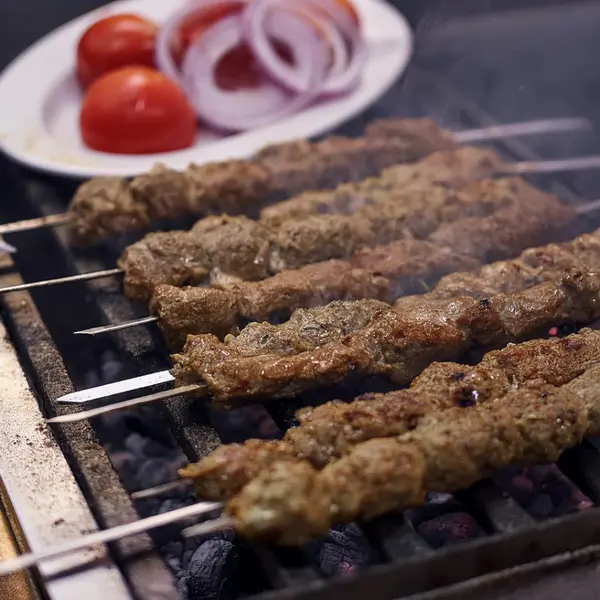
[118,178,575,300]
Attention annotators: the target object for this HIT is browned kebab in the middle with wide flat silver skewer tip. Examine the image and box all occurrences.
[52,270,600,412]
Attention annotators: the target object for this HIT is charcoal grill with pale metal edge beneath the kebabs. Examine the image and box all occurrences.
[0,2,600,600]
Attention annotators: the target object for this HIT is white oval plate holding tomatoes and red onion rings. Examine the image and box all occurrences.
[0,0,412,178]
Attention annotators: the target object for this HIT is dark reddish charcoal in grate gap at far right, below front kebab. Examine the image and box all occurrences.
[492,465,592,519]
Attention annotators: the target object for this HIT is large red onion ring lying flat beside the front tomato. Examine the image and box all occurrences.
[182,15,329,131]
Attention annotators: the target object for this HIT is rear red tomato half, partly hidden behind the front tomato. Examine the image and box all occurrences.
[77,14,158,88]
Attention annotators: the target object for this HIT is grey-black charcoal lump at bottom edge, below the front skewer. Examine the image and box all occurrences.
[179,538,240,600]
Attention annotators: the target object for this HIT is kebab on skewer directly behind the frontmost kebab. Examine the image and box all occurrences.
[135,330,600,536]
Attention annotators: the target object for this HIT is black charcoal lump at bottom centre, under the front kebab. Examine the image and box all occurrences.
[313,523,378,577]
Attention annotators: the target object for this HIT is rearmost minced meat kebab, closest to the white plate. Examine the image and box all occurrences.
[69,119,455,243]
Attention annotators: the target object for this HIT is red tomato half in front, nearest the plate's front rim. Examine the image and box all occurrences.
[79,67,196,154]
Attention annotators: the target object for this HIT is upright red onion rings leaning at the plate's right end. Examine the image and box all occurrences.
[243,0,367,94]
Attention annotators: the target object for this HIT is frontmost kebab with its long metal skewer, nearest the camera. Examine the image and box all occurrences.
[5,344,600,575]
